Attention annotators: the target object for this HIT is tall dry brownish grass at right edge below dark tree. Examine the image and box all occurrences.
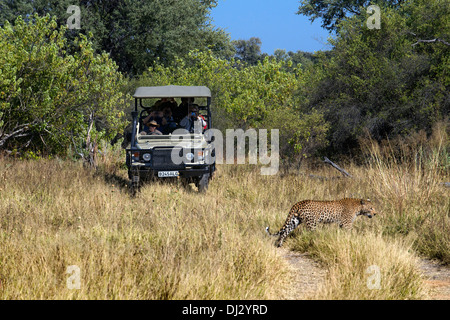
[366,123,450,264]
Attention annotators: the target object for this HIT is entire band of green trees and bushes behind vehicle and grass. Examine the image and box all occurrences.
[0,0,450,164]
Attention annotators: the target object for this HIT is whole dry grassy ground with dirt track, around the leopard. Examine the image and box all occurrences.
[0,124,450,299]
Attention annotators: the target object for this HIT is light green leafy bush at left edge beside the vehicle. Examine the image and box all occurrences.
[0,15,124,160]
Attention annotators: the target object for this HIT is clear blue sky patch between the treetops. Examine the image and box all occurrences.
[211,0,330,54]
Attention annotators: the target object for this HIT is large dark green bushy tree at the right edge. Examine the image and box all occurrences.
[300,0,450,152]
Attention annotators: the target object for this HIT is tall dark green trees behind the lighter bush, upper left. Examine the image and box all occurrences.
[0,0,234,75]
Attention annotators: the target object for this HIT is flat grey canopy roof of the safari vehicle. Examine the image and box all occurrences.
[133,86,211,99]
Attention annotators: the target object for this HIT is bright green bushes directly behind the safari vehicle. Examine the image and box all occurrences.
[139,51,328,160]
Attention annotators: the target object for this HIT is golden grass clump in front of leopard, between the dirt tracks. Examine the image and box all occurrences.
[292,227,427,300]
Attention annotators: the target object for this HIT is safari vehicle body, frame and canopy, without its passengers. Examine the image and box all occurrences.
[126,86,215,194]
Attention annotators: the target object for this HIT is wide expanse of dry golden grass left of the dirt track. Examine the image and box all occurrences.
[0,159,288,299]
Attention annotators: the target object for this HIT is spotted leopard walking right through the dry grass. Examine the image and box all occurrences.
[266,198,377,247]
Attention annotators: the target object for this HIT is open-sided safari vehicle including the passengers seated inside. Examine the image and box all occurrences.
[125,86,216,194]
